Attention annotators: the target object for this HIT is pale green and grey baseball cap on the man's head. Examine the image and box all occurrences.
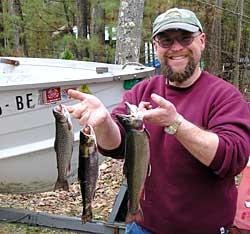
[152,8,203,38]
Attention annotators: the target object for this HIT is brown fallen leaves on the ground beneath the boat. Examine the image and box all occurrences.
[0,158,123,221]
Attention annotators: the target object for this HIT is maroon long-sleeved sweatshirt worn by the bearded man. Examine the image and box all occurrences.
[98,72,250,234]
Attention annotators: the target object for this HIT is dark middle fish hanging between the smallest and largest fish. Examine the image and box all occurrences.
[78,125,99,223]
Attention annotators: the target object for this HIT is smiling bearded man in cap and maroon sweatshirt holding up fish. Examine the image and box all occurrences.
[68,8,250,234]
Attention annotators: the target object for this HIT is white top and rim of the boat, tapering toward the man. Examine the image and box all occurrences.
[0,57,155,91]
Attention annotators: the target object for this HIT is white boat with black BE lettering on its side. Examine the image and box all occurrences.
[0,58,152,193]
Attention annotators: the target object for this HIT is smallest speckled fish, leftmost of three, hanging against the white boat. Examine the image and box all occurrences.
[53,104,74,191]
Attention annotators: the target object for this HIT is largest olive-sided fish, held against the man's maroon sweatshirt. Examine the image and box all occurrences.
[116,102,150,223]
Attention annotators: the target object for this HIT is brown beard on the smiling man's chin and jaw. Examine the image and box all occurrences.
[161,56,197,83]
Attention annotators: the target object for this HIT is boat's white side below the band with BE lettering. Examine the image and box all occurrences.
[0,82,124,193]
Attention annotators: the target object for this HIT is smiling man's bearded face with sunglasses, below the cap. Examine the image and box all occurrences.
[153,30,205,83]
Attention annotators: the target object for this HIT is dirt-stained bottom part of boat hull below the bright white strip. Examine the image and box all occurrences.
[0,141,78,193]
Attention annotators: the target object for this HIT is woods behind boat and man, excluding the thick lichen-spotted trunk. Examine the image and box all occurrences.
[0,0,250,101]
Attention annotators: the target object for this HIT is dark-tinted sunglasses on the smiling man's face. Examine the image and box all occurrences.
[154,32,201,48]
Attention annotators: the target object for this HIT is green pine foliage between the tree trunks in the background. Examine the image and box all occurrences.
[0,0,250,72]
